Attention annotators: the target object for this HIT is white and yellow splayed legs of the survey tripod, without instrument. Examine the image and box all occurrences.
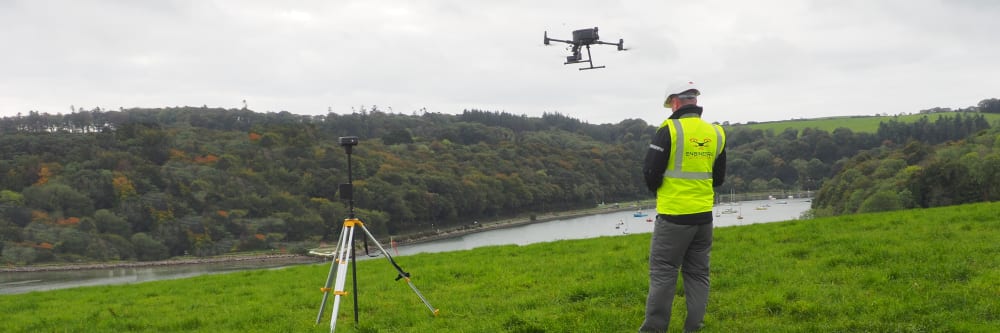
[316,218,438,333]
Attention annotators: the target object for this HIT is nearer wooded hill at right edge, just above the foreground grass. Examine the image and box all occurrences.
[813,128,1000,216]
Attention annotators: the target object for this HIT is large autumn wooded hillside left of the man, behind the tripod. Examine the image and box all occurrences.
[0,107,652,263]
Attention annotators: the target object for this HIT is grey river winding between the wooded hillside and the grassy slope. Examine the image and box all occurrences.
[0,199,810,294]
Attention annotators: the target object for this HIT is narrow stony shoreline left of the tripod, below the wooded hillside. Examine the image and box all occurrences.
[0,254,321,273]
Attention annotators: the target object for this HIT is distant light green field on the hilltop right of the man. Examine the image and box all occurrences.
[735,112,1000,134]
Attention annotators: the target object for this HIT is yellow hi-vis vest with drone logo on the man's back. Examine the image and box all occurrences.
[656,114,726,215]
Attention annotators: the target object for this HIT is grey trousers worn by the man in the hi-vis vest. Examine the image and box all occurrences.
[639,218,712,332]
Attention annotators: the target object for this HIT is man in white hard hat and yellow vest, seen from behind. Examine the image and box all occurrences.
[639,82,726,332]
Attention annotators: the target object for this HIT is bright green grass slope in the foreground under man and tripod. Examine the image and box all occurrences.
[0,203,1000,332]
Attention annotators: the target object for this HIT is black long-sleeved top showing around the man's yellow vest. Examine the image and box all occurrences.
[642,105,726,224]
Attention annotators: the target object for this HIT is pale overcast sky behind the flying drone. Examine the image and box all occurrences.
[0,0,1000,124]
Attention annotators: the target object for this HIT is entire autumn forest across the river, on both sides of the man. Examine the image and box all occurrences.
[0,102,1000,265]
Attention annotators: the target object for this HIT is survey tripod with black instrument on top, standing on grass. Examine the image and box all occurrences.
[316,136,438,333]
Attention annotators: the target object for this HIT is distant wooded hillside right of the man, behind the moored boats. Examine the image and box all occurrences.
[722,112,991,193]
